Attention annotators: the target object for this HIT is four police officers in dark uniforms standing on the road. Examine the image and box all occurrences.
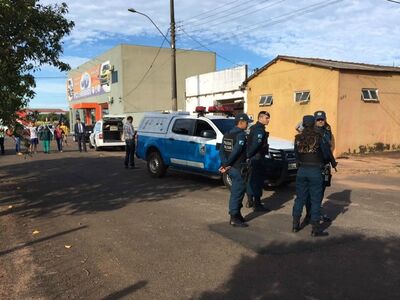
[220,111,337,236]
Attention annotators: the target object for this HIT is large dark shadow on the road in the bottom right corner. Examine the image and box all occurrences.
[195,234,400,300]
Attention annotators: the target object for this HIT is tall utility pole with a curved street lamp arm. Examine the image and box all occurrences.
[128,0,178,111]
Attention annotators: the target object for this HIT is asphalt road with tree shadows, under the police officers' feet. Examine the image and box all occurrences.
[0,144,400,299]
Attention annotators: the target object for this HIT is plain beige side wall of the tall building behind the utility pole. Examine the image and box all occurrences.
[118,45,216,113]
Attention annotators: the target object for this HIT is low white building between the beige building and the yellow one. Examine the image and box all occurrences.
[185,65,247,112]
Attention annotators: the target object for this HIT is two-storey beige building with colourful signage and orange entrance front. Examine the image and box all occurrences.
[67,45,216,124]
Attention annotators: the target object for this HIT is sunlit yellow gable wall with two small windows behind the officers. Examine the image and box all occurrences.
[247,60,339,144]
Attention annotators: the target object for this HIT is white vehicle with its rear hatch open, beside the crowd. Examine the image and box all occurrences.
[89,115,125,150]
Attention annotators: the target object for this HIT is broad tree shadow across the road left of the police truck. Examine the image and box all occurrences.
[0,157,220,217]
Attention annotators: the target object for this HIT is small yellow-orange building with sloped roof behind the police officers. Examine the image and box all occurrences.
[245,56,400,155]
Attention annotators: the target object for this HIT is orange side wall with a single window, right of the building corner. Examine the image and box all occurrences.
[337,72,400,153]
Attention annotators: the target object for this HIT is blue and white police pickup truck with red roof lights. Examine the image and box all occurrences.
[136,112,297,187]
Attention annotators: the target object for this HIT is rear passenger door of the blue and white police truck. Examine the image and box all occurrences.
[166,118,198,169]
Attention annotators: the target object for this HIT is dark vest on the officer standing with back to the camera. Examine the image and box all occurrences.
[295,131,323,166]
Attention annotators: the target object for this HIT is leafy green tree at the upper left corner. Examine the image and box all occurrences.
[0,0,74,124]
